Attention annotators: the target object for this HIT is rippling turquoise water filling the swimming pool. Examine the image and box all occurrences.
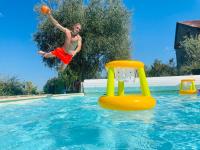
[0,89,200,150]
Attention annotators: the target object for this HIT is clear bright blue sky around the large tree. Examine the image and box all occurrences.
[0,0,200,89]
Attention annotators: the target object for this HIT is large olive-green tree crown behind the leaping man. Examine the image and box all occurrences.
[34,0,131,92]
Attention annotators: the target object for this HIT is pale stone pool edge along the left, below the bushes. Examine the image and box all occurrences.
[0,93,84,103]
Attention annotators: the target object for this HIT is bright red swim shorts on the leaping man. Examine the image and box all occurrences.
[51,47,72,64]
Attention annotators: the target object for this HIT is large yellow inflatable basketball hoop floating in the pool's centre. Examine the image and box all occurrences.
[99,60,156,111]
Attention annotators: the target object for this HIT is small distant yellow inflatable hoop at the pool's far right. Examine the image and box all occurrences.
[179,79,197,94]
